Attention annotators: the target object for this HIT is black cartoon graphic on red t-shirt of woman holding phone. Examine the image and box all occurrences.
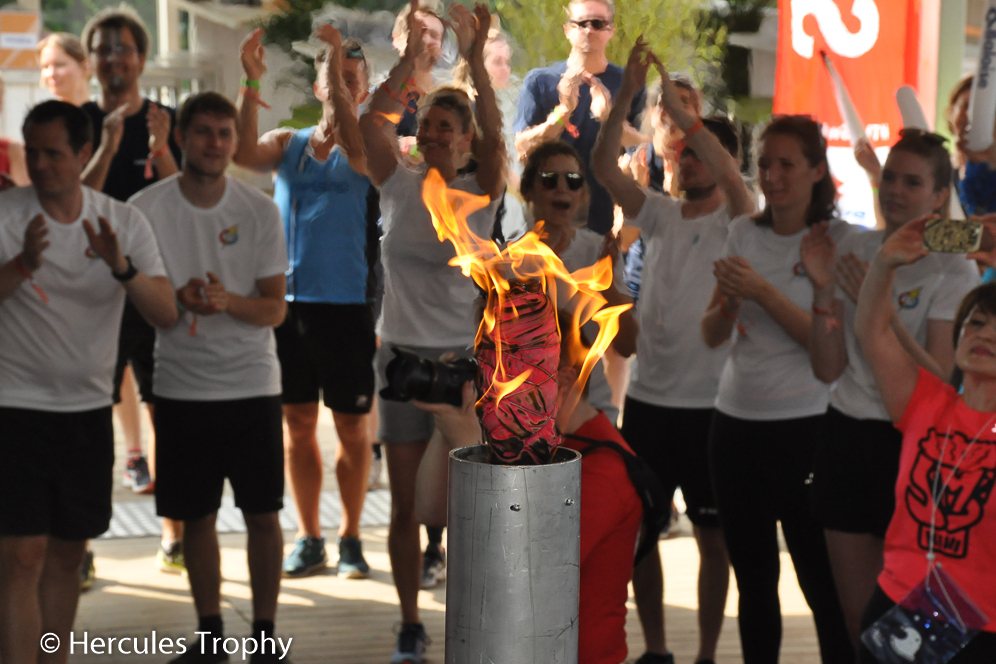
[906,427,996,558]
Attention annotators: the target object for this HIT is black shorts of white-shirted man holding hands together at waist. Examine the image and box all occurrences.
[155,396,284,521]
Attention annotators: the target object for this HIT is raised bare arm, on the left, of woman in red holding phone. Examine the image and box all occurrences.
[854,219,927,422]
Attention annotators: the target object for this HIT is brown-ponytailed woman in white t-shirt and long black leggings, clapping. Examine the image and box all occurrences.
[702,116,854,664]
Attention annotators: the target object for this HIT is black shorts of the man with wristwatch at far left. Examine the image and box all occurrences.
[0,406,114,540]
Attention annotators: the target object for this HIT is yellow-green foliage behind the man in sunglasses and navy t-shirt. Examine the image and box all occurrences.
[494,0,726,85]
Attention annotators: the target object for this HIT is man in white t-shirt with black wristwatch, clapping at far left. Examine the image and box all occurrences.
[0,101,177,663]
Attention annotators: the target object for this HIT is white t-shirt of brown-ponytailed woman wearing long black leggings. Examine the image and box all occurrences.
[716,215,856,420]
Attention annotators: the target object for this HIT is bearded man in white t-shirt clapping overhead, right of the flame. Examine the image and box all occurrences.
[592,43,754,664]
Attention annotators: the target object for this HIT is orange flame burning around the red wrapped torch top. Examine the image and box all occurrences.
[422,169,632,456]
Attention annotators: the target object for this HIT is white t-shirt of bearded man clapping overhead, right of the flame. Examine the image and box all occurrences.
[627,190,730,408]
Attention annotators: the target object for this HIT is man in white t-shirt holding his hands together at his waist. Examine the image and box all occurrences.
[131,92,287,664]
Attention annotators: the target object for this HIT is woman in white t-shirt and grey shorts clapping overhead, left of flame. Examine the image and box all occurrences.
[360,3,505,661]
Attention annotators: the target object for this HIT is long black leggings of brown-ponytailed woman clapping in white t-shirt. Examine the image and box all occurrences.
[709,411,854,664]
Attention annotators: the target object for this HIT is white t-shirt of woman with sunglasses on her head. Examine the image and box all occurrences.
[830,231,980,421]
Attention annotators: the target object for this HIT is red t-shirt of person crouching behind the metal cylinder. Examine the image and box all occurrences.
[564,411,643,664]
